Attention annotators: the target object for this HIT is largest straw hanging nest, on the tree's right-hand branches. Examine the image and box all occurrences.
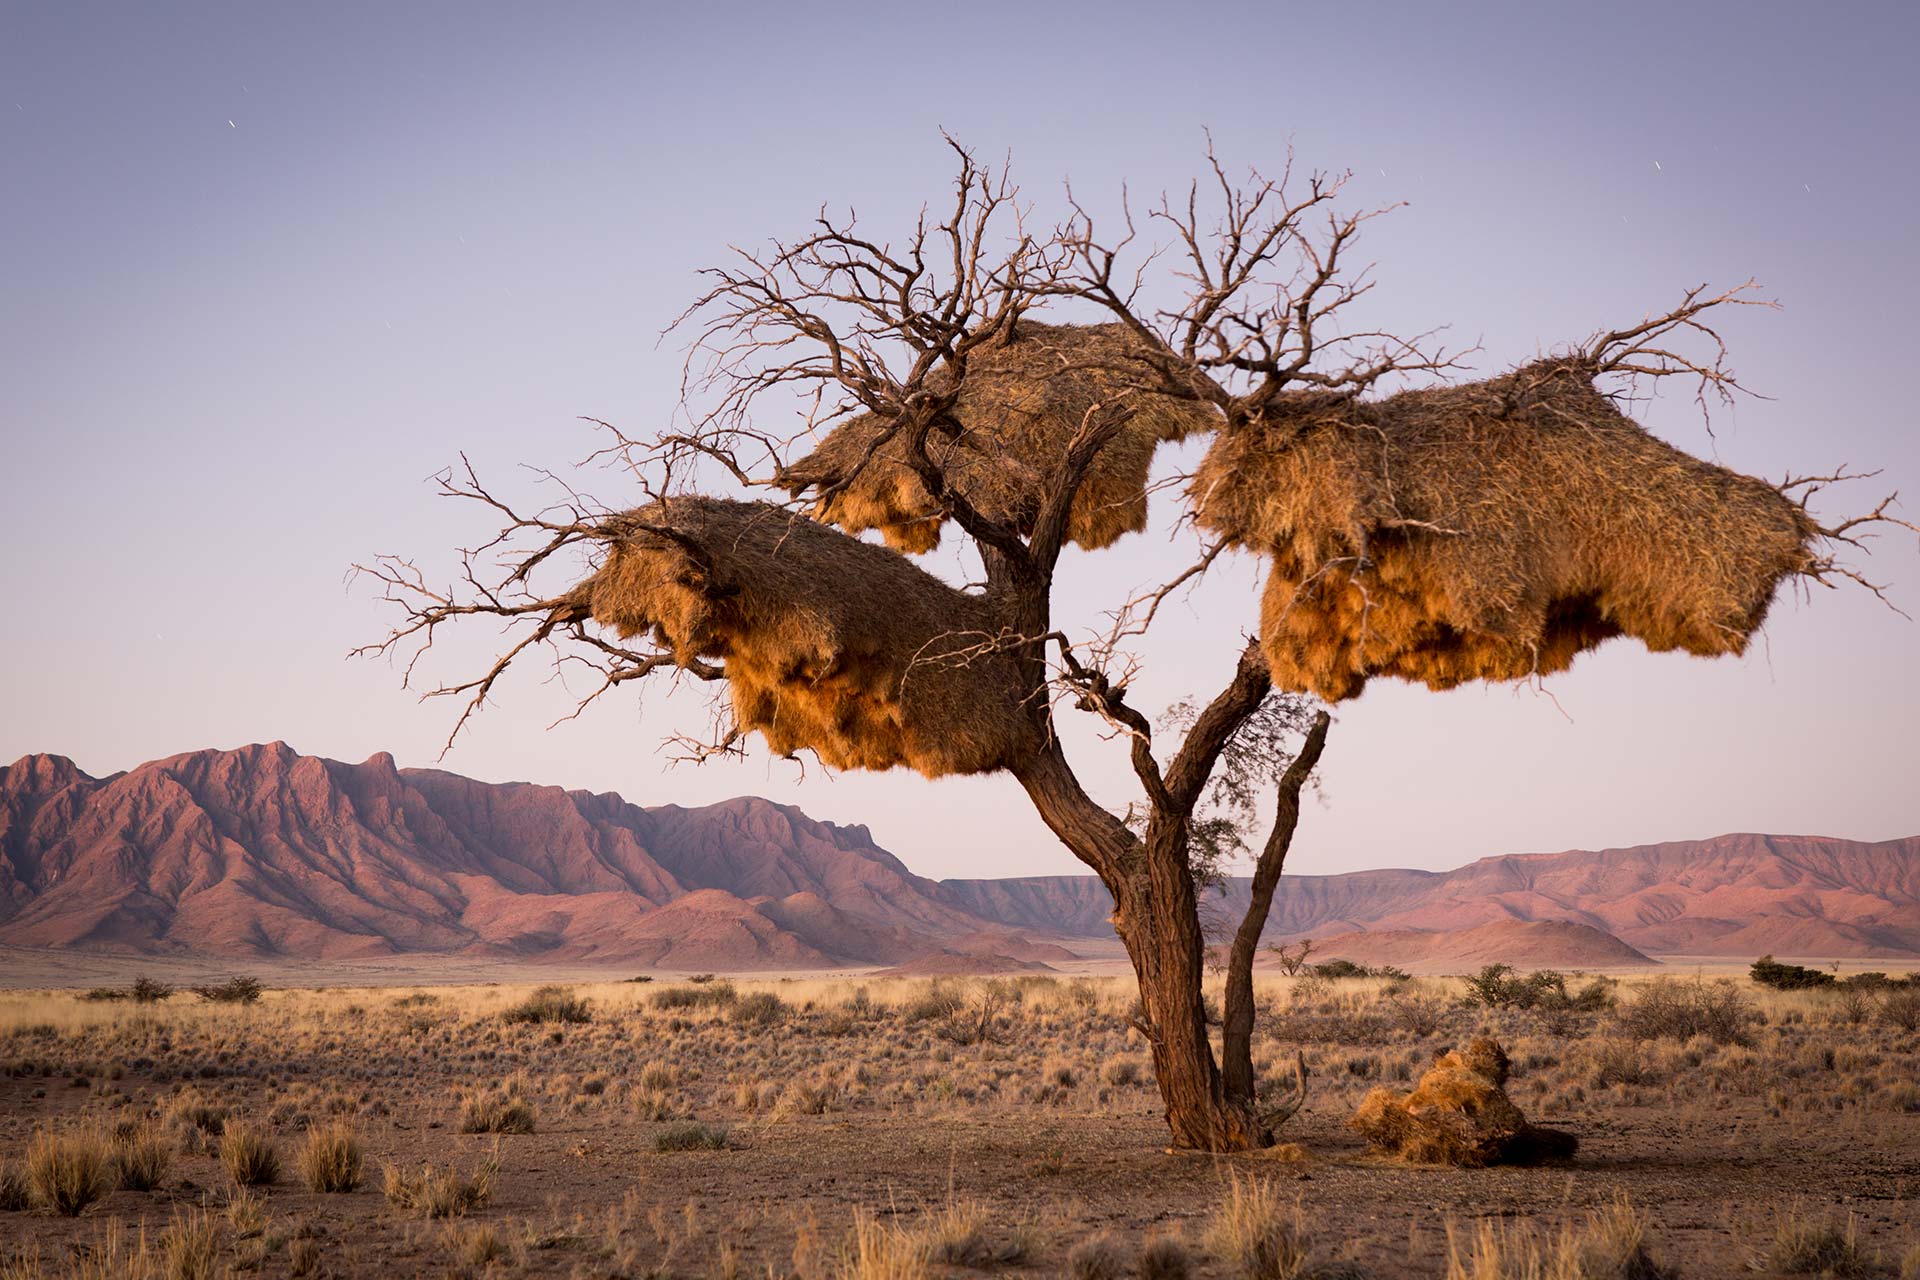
[1192,361,1820,702]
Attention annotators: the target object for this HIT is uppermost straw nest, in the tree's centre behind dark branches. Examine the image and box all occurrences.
[776,320,1221,553]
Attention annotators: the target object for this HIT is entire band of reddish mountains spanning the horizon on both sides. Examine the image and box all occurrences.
[0,743,1920,971]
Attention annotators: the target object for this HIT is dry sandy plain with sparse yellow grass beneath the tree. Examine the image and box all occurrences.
[0,975,1920,1276]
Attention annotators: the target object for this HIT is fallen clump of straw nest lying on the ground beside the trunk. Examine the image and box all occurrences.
[1348,1036,1578,1169]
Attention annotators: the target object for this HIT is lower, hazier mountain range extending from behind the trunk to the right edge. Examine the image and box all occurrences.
[941,835,1920,958]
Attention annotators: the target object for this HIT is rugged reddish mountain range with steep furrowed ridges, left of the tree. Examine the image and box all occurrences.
[0,743,1021,969]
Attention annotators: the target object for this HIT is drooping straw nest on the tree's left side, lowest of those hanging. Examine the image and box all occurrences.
[568,497,1037,777]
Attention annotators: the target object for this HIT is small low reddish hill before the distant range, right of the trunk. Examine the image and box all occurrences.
[1313,919,1659,973]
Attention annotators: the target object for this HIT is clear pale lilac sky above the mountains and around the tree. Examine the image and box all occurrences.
[0,0,1920,877]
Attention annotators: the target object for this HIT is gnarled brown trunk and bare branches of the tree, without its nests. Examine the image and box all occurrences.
[363,146,1904,1151]
